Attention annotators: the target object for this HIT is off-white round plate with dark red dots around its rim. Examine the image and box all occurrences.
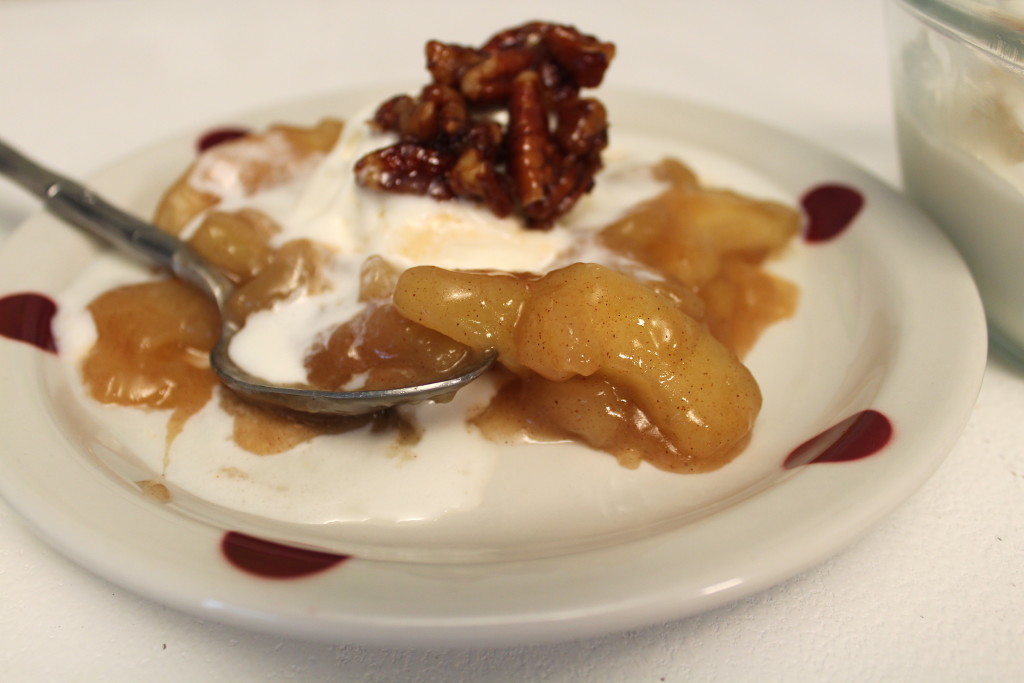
[0,91,986,645]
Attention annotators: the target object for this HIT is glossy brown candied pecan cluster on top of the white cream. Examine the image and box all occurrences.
[355,22,615,228]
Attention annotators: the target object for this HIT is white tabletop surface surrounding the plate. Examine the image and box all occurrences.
[0,0,1024,682]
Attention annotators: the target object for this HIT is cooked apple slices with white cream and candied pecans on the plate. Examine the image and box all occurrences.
[66,23,801,472]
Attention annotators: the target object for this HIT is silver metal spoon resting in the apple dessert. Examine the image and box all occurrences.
[0,140,495,416]
